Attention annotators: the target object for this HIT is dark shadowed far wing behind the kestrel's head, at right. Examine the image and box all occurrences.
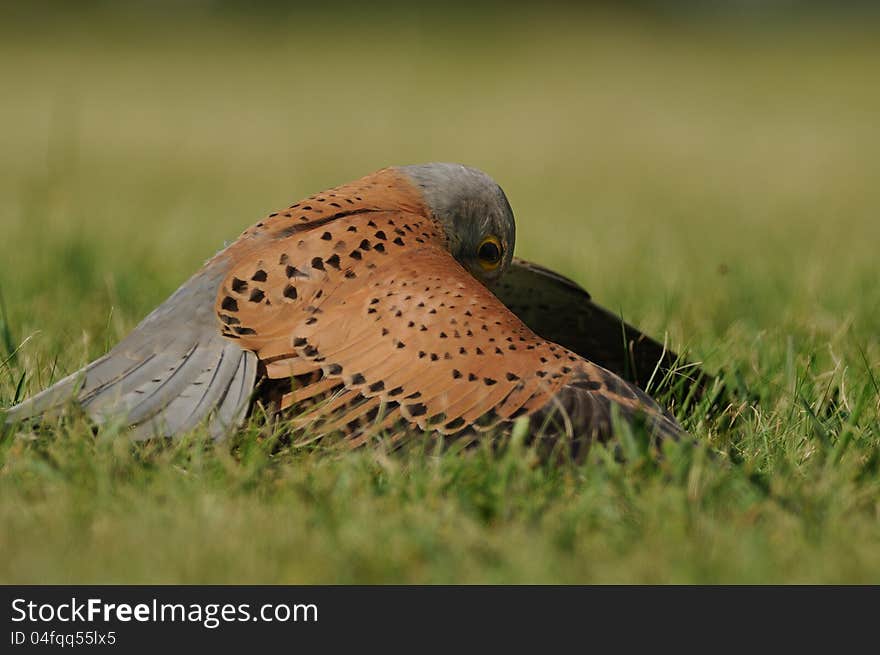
[494,258,709,400]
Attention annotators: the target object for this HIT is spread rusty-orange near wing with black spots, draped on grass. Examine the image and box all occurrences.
[216,211,680,452]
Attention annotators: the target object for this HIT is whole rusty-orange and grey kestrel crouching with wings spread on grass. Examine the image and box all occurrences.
[5,163,685,452]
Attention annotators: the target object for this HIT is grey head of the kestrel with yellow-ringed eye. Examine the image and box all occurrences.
[398,163,516,286]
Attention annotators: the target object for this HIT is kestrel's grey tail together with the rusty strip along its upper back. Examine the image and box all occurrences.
[4,169,424,439]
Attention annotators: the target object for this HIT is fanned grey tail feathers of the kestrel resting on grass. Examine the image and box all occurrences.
[6,254,257,439]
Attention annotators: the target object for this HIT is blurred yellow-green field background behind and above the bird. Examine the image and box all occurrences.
[0,3,880,364]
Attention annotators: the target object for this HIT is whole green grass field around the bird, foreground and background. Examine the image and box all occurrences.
[0,8,880,583]
